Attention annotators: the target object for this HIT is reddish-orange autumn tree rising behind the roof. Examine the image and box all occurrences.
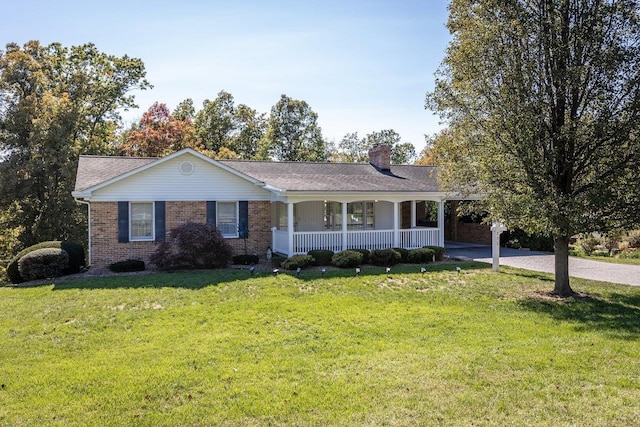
[120,102,199,157]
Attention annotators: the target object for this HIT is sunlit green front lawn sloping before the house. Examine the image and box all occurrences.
[0,264,640,426]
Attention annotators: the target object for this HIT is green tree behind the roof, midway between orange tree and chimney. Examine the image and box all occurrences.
[258,95,327,162]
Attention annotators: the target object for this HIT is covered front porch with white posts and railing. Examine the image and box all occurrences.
[272,200,444,256]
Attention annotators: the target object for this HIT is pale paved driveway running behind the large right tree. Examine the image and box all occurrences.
[445,242,640,286]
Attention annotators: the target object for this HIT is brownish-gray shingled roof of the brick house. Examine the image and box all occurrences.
[75,156,440,192]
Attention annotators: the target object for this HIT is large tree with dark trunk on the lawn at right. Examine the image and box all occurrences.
[427,0,640,295]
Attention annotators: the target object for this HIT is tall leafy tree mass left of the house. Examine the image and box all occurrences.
[0,41,150,258]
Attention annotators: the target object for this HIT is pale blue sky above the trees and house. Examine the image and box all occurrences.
[0,0,450,151]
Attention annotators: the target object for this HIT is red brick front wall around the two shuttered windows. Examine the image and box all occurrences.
[90,201,271,268]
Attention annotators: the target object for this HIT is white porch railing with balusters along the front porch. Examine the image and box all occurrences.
[272,228,444,255]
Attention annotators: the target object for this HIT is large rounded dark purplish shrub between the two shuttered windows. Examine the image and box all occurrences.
[150,222,232,270]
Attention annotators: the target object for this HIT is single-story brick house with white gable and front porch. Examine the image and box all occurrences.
[72,146,488,267]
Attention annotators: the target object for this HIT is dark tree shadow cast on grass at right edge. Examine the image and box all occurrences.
[521,293,640,340]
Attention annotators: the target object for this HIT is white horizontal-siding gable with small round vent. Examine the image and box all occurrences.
[91,153,271,201]
